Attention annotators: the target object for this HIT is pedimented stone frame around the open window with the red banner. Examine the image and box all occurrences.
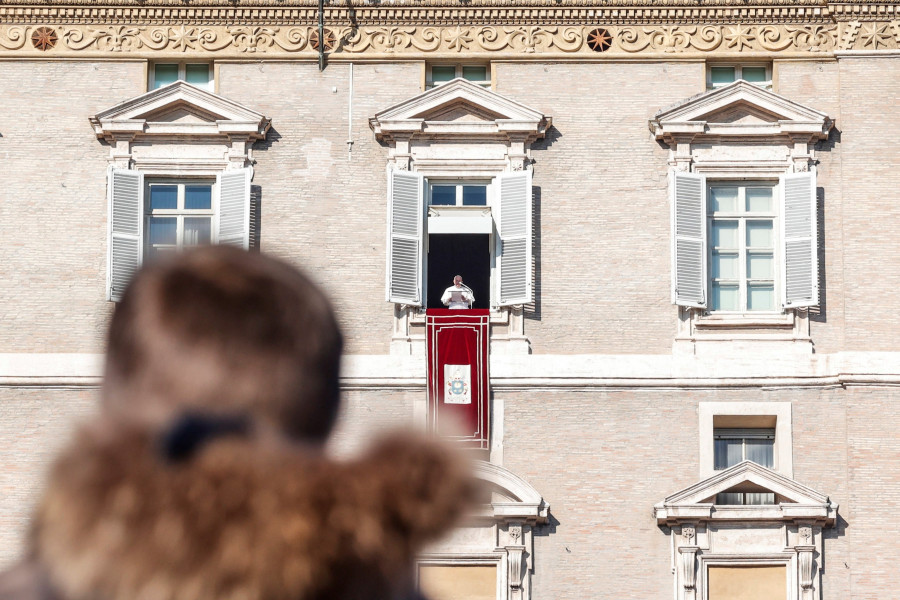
[369,79,551,354]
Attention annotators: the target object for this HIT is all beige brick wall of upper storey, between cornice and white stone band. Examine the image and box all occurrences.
[0,59,900,353]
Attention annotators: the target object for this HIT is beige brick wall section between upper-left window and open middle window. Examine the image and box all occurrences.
[219,62,421,354]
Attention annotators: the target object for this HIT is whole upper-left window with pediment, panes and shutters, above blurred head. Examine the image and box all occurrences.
[91,81,269,301]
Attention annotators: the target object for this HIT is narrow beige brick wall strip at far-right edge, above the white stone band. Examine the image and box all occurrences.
[838,58,900,350]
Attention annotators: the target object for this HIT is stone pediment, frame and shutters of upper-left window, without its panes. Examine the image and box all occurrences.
[90,81,270,302]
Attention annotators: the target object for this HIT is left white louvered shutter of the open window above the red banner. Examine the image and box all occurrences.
[387,171,425,306]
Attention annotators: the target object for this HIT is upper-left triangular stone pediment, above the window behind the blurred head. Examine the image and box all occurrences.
[91,81,269,139]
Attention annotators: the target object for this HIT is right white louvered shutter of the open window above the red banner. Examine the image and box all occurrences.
[496,171,531,306]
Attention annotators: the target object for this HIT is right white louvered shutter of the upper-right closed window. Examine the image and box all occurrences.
[781,172,819,308]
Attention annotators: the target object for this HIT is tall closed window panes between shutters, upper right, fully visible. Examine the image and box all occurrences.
[707,183,780,313]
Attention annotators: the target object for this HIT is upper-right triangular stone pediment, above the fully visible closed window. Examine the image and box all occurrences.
[650,80,832,141]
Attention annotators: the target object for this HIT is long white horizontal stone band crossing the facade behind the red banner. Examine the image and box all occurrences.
[0,352,900,390]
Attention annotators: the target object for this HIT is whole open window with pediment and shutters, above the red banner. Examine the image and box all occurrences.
[370,79,550,352]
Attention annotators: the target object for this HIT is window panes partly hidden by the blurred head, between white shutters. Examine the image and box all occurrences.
[146,181,213,259]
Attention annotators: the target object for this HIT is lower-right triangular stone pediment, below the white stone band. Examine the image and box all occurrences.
[656,461,837,520]
